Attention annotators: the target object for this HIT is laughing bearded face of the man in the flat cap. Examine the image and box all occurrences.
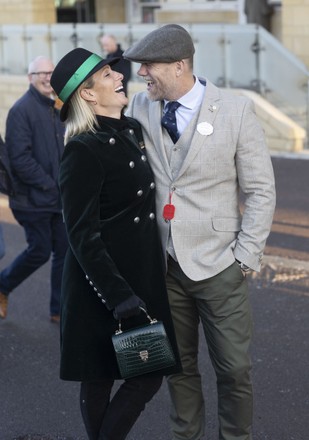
[137,63,177,101]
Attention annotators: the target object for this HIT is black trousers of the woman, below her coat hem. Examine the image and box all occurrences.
[80,375,163,440]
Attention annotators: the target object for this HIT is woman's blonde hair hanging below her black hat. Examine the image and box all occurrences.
[64,77,98,144]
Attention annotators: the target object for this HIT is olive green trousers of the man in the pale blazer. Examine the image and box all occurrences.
[167,258,252,440]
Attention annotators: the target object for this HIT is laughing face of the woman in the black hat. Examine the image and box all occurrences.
[89,65,129,117]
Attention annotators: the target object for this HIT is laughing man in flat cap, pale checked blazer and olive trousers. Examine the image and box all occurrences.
[124,24,275,440]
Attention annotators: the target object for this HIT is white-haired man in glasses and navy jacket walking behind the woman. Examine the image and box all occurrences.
[0,56,67,322]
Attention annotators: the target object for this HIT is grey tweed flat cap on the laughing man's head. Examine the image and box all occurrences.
[123,24,195,63]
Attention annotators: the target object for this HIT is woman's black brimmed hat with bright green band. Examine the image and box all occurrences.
[50,47,120,121]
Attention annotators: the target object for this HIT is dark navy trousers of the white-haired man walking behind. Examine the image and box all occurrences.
[0,209,67,315]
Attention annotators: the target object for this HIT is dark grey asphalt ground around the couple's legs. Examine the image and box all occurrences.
[0,156,309,440]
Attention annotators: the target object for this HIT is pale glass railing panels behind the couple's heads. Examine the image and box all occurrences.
[0,24,309,138]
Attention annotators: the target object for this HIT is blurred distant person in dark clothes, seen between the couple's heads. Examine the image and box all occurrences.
[99,34,132,95]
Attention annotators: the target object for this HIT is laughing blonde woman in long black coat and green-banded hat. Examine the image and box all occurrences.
[51,48,180,440]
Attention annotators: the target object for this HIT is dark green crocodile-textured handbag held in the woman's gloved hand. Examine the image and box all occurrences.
[112,308,176,379]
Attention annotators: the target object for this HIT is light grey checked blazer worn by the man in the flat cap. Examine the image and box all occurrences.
[127,80,275,281]
